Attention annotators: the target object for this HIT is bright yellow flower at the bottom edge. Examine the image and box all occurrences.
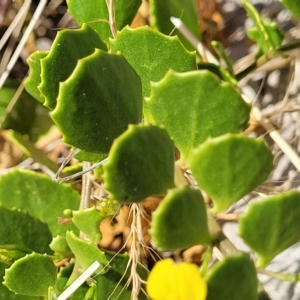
[147,259,207,300]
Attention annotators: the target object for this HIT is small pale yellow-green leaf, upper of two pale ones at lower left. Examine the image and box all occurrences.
[72,207,106,244]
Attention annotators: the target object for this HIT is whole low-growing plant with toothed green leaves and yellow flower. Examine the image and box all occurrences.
[0,0,300,300]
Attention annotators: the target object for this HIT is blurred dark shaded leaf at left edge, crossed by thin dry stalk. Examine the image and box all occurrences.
[0,82,37,134]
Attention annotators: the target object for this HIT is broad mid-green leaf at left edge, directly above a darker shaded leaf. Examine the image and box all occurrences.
[0,170,80,236]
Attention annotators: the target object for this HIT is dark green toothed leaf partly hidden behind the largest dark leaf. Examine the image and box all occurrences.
[38,24,107,109]
